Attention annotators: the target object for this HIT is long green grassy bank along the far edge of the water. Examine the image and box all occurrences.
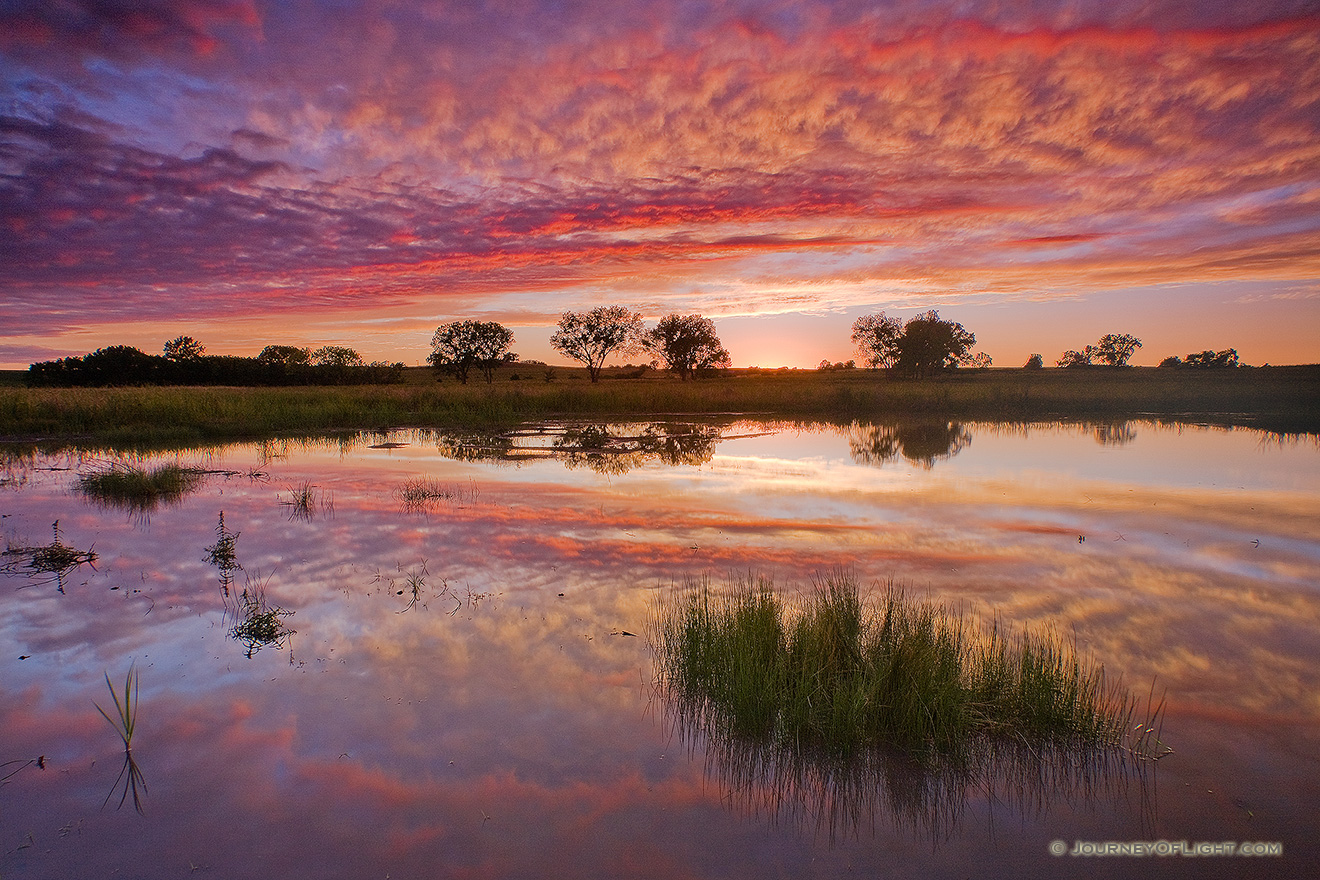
[0,367,1320,447]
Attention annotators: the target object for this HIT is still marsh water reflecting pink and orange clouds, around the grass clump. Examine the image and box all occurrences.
[0,418,1320,877]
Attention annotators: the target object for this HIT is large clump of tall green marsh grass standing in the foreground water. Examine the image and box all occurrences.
[652,574,1167,757]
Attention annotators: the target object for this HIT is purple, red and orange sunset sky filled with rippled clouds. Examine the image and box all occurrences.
[0,0,1320,369]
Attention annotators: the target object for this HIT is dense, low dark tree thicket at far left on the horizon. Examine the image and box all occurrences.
[28,346,404,387]
